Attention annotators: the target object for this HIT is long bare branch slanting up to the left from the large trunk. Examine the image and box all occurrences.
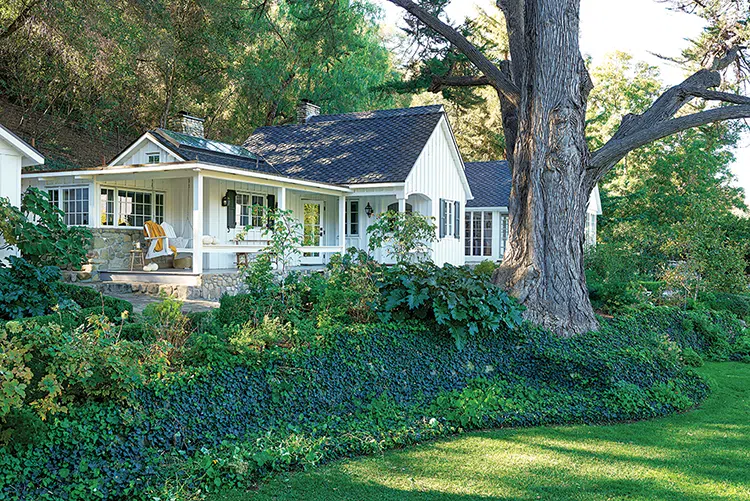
[388,0,520,105]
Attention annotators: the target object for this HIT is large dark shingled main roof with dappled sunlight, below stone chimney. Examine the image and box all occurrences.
[244,105,444,185]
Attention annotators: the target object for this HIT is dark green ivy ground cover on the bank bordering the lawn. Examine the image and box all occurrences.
[0,300,728,500]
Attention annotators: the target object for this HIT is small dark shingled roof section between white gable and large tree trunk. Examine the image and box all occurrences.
[465,160,511,208]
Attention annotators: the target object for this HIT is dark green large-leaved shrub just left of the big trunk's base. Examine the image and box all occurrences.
[380,263,521,348]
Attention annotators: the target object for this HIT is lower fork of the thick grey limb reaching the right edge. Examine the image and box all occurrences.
[589,104,750,172]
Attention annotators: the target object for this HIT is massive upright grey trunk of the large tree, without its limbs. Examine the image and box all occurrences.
[494,0,598,335]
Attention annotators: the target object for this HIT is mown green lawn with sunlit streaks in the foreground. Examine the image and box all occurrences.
[213,363,750,501]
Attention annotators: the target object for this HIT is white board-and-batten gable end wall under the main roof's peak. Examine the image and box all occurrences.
[404,117,467,266]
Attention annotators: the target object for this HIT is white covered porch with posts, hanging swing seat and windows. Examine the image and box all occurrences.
[86,164,351,274]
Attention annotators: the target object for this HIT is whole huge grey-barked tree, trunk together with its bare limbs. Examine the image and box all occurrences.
[389,0,750,336]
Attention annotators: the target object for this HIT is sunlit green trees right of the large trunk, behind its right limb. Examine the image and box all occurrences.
[587,53,750,298]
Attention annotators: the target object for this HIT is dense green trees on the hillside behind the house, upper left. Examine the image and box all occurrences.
[0,0,402,144]
